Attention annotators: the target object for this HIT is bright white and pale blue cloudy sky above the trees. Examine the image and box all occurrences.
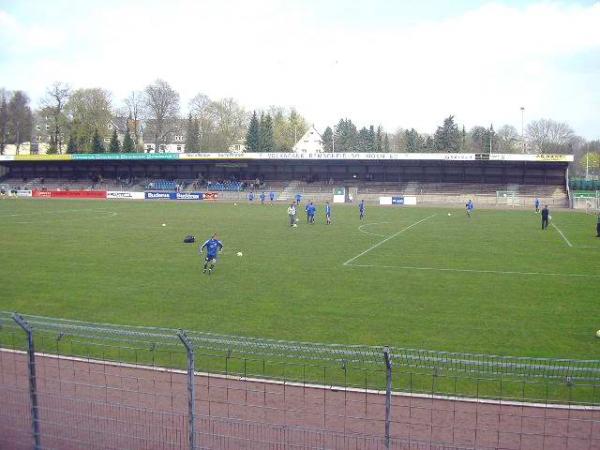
[0,0,600,139]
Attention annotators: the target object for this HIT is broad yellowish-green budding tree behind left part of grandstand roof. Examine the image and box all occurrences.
[66,88,112,152]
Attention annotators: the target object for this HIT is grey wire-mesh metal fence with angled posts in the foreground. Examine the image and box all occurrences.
[0,312,600,450]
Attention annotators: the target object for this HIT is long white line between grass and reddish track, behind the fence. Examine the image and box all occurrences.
[0,348,600,411]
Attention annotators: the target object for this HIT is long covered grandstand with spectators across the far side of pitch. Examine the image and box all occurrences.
[0,153,575,207]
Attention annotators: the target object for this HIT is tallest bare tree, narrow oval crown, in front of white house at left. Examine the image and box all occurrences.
[144,79,179,152]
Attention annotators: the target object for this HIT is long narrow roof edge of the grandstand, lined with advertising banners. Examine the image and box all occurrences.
[0,152,573,162]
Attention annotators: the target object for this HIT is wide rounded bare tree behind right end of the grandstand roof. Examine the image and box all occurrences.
[526,119,575,153]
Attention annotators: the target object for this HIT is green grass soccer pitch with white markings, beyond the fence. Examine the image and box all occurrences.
[0,200,600,359]
